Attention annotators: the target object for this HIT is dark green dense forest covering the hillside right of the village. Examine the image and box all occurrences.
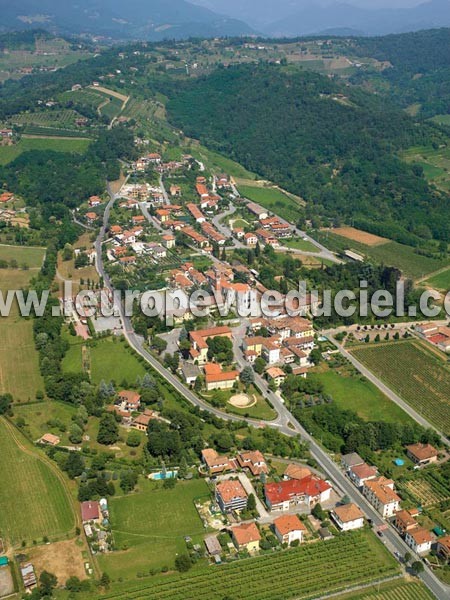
[167,65,450,243]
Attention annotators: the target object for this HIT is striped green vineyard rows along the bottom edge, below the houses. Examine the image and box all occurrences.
[96,532,399,600]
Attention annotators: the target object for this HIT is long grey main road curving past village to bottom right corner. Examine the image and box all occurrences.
[95,187,450,600]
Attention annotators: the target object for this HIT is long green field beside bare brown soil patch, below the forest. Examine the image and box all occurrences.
[312,230,450,280]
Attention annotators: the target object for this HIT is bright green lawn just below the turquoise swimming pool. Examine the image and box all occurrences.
[98,479,209,579]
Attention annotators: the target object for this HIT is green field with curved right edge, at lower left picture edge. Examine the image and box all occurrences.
[0,419,75,546]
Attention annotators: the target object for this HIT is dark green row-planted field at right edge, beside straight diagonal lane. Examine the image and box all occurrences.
[352,341,450,435]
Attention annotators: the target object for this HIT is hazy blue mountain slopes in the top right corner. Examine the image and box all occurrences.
[192,0,450,37]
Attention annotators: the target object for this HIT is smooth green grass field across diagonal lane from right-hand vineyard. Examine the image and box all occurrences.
[310,370,412,423]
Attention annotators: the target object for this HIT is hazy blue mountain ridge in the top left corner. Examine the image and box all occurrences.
[0,0,254,41]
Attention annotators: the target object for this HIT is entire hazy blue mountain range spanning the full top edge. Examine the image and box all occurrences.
[0,0,450,41]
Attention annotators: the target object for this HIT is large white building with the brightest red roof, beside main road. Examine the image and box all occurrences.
[264,475,331,510]
